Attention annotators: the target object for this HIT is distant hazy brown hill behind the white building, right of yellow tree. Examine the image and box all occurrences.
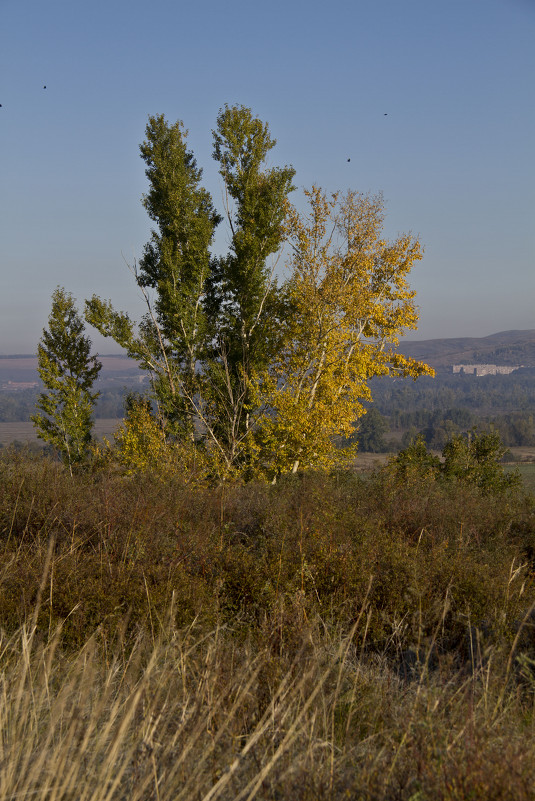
[399,329,535,367]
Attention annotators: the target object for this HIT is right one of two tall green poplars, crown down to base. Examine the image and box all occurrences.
[206,106,295,458]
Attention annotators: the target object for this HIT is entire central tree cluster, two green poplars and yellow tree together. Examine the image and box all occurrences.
[86,106,432,478]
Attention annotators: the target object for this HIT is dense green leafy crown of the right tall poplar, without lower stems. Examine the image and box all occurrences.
[209,106,295,360]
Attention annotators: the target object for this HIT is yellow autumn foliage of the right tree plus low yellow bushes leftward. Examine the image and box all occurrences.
[92,187,433,480]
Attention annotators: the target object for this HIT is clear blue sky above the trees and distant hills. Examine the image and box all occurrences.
[0,0,535,354]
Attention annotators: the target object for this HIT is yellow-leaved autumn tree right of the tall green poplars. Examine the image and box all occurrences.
[253,187,433,473]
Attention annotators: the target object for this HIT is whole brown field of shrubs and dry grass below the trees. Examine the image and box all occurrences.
[0,454,535,801]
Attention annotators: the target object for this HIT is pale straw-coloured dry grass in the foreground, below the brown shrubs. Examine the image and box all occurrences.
[0,607,535,801]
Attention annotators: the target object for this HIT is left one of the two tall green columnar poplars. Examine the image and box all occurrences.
[137,115,221,431]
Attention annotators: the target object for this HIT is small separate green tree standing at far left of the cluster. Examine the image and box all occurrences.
[31,287,102,475]
